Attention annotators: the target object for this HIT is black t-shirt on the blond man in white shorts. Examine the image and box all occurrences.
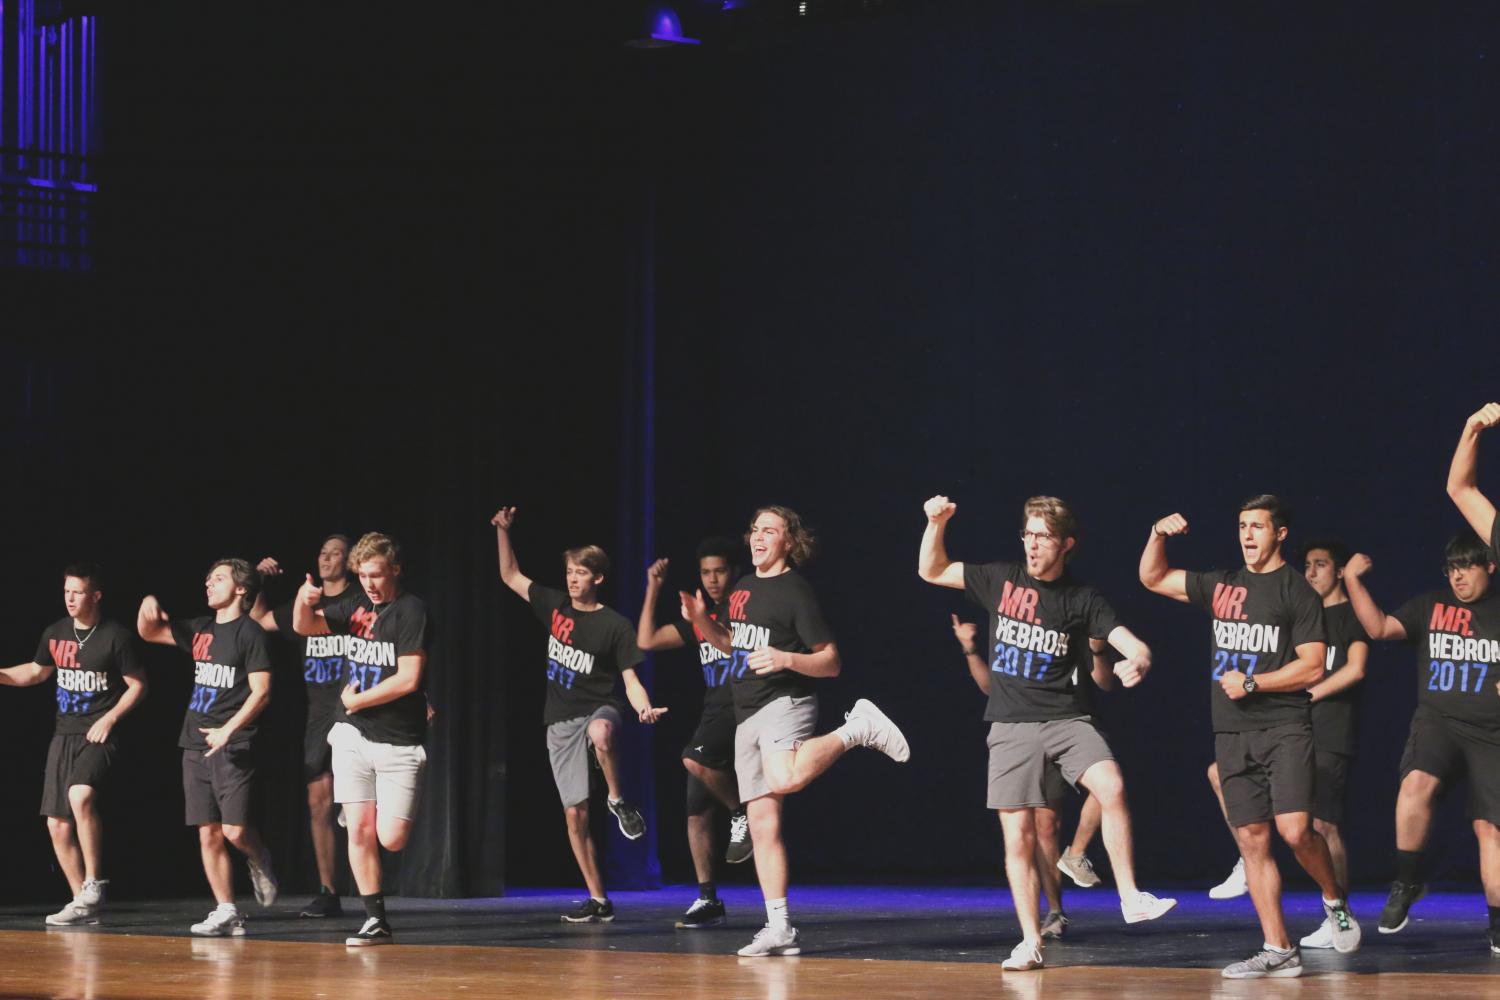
[323,586,428,747]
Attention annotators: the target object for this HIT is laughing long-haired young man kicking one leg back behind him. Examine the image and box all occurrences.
[680,507,911,958]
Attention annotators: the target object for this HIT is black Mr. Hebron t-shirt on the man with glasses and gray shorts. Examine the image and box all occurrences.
[963,562,1121,723]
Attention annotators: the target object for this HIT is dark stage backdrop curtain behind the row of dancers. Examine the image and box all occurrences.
[0,3,1500,898]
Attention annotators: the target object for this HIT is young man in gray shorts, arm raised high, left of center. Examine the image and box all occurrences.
[491,507,666,924]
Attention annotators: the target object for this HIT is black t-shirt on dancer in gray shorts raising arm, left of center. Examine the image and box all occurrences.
[530,583,645,726]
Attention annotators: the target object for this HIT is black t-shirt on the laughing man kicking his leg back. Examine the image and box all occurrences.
[725,570,834,723]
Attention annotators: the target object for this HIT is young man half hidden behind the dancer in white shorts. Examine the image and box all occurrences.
[251,535,350,918]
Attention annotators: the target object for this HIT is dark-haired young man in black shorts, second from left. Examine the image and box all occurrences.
[135,559,276,937]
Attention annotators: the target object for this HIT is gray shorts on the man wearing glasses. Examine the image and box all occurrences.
[986,717,1115,810]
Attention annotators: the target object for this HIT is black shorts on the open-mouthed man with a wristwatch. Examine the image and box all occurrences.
[1214,723,1317,826]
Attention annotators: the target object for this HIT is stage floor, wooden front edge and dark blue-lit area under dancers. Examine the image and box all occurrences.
[0,886,1500,1000]
